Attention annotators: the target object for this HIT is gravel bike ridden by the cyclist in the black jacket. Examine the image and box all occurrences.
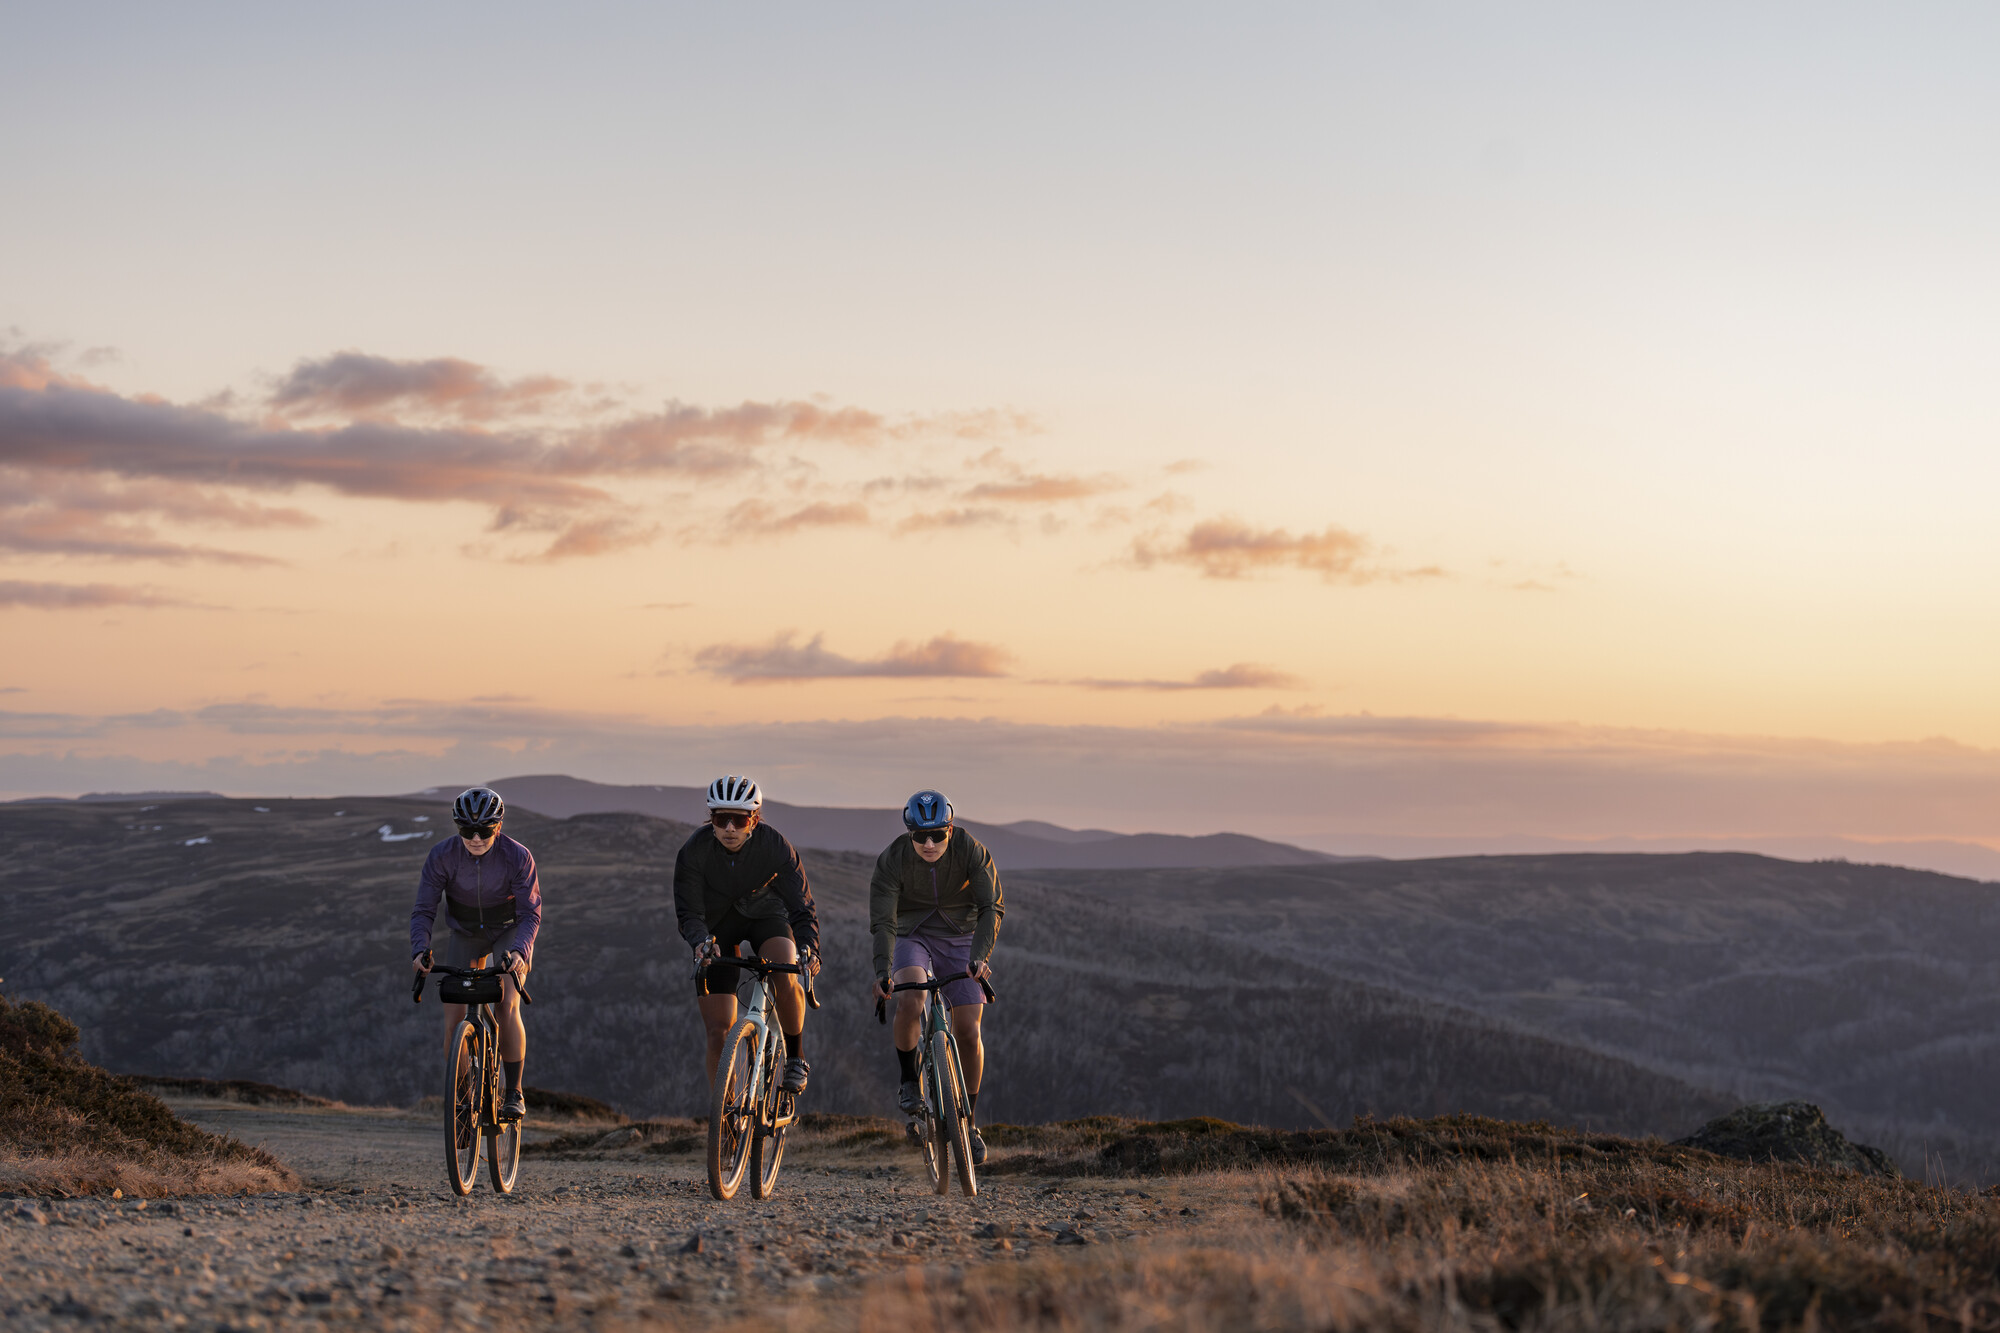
[694,959,820,1199]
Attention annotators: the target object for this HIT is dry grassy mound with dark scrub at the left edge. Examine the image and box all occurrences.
[0,984,298,1197]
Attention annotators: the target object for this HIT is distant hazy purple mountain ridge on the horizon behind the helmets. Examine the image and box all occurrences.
[430,773,1374,875]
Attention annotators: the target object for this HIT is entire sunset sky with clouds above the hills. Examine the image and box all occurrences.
[0,4,2000,851]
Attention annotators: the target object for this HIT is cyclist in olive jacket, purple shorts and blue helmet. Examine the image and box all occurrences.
[868,791,1006,1165]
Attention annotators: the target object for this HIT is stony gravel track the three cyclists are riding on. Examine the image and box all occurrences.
[0,1101,1254,1329]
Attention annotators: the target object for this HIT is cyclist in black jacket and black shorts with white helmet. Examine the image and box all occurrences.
[674,777,820,1093]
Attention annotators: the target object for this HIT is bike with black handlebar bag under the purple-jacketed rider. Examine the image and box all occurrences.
[410,955,534,1195]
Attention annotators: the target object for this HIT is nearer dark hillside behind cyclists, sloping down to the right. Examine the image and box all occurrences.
[0,799,1728,1133]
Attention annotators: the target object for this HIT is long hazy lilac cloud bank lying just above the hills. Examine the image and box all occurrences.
[0,701,2000,845]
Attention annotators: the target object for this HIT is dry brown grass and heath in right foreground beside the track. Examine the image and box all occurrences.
[724,1119,2000,1333]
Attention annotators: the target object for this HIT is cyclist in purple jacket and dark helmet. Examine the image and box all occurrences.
[410,787,542,1121]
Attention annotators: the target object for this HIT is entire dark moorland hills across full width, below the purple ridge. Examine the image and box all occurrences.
[0,799,2000,1177]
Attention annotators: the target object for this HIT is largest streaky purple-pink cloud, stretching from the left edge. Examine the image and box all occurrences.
[0,348,1028,558]
